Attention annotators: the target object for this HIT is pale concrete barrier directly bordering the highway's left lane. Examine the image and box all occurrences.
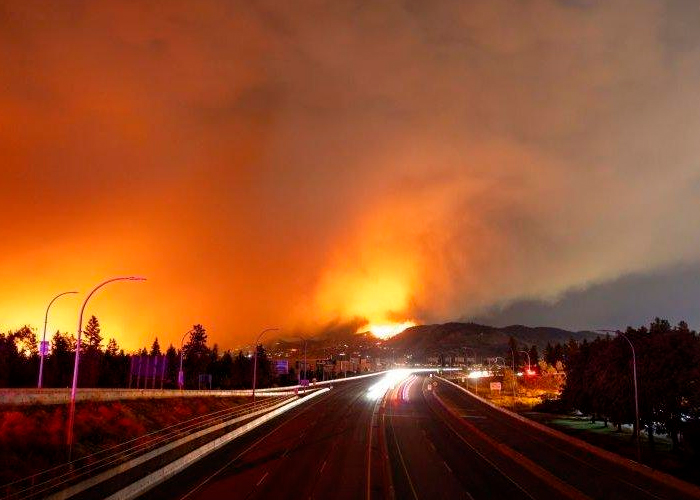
[107,388,330,500]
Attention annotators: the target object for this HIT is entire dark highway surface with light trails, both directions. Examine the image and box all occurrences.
[139,375,698,500]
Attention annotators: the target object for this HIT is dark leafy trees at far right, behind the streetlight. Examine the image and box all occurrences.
[561,318,700,450]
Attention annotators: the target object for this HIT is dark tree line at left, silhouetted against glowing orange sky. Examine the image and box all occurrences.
[0,316,296,389]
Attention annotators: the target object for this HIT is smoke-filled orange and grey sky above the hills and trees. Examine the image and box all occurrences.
[0,0,700,349]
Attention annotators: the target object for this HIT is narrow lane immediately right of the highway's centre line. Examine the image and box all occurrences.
[384,377,471,500]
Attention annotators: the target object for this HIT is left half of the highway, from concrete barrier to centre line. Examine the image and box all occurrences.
[142,377,386,500]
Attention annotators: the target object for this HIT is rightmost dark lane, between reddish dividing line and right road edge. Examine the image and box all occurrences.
[437,382,692,499]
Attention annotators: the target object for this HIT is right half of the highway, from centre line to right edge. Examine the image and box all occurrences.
[384,377,697,500]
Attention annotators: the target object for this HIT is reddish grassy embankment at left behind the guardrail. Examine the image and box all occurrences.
[0,397,244,485]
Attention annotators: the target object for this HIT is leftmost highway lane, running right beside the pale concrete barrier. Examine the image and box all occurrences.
[142,377,374,500]
